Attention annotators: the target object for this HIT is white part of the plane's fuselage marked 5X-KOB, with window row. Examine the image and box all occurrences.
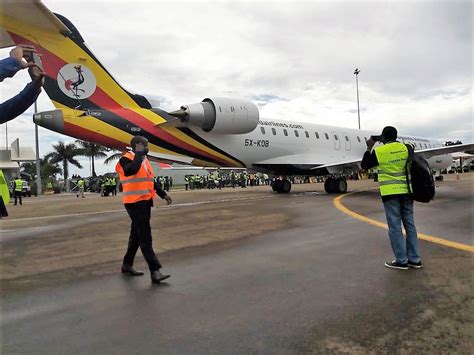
[195,119,452,175]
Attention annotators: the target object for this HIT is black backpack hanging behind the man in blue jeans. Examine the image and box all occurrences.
[406,145,435,203]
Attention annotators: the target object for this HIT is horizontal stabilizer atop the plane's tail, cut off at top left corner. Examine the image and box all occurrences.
[0,0,70,48]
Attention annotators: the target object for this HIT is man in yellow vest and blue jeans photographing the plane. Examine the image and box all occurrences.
[361,126,423,270]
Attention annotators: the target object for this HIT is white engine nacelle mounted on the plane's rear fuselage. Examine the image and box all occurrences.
[171,97,259,134]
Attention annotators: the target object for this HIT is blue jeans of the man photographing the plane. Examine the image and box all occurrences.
[383,196,421,264]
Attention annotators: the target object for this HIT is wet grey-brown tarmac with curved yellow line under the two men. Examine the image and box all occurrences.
[0,173,474,354]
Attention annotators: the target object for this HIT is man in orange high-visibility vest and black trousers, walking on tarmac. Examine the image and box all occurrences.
[115,136,172,283]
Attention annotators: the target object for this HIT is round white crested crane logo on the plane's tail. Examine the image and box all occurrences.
[56,63,97,100]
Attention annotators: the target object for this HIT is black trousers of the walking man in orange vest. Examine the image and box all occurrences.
[123,200,161,272]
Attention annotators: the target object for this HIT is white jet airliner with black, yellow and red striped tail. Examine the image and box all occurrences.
[0,0,474,193]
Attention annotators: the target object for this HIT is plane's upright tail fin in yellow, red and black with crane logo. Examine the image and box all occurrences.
[0,0,151,110]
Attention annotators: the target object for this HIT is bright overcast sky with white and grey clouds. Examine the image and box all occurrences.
[0,0,474,176]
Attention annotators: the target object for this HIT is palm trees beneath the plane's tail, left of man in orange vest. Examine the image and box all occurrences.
[21,140,122,181]
